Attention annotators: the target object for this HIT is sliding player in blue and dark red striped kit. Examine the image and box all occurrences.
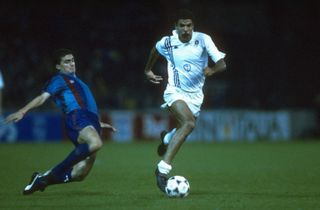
[6,49,116,195]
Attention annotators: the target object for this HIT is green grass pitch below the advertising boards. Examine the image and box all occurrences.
[0,141,320,210]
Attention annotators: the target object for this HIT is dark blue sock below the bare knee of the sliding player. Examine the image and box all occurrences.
[50,144,90,182]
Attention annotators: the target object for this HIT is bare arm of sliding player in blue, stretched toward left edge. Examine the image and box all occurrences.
[5,92,50,123]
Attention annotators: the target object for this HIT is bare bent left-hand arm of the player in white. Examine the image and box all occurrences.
[144,47,163,84]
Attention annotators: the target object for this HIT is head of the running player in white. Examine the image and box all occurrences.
[175,9,194,42]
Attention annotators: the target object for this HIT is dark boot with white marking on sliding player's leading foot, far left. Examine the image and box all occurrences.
[22,172,47,195]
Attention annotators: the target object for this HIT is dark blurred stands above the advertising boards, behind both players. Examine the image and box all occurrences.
[0,0,320,110]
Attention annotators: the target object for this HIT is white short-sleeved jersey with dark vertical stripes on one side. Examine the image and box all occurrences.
[156,30,225,92]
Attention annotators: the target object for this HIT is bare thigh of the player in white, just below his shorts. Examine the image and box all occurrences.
[170,100,195,125]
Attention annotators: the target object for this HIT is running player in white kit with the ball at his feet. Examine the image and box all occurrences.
[145,10,226,192]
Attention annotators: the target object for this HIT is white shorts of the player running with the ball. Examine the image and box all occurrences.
[161,86,203,117]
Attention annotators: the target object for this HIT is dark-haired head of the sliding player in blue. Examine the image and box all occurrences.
[53,48,76,73]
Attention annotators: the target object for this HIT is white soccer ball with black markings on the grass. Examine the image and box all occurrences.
[165,175,190,198]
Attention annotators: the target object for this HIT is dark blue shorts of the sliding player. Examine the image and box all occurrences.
[65,109,101,146]
